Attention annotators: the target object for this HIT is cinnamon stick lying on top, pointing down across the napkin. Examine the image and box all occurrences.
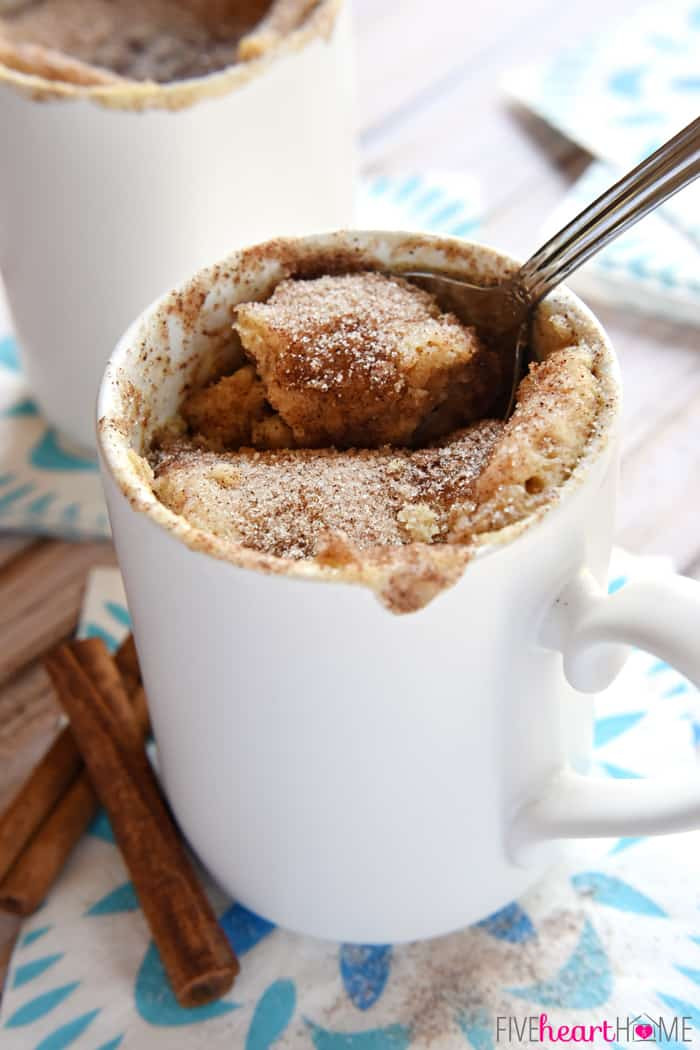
[46,639,238,1007]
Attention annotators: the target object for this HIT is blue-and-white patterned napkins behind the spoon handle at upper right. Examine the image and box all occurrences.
[506,0,700,323]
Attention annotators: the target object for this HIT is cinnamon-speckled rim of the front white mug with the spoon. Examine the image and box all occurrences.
[97,230,621,604]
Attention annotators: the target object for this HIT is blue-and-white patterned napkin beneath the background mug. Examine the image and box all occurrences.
[0,172,480,540]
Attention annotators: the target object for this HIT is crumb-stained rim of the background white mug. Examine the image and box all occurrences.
[0,0,345,111]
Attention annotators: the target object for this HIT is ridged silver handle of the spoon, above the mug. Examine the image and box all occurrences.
[516,118,700,303]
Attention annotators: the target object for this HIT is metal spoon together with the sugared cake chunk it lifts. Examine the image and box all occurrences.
[182,119,700,450]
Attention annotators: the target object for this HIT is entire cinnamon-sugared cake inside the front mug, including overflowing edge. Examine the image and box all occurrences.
[145,264,606,612]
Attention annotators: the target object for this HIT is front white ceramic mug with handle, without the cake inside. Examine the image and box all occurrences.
[99,233,700,942]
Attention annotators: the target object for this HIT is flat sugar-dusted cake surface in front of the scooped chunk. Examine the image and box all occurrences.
[153,421,503,564]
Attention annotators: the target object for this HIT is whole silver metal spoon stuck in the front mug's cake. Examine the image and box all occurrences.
[397,118,700,419]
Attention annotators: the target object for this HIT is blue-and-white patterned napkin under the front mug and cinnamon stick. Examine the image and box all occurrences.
[0,552,700,1050]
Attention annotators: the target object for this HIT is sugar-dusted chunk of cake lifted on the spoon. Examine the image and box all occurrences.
[236,272,501,447]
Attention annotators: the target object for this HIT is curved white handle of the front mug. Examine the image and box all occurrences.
[508,569,700,864]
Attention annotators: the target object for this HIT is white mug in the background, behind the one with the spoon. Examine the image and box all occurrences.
[0,0,355,448]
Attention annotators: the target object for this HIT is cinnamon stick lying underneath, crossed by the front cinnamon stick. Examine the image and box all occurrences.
[0,635,149,916]
